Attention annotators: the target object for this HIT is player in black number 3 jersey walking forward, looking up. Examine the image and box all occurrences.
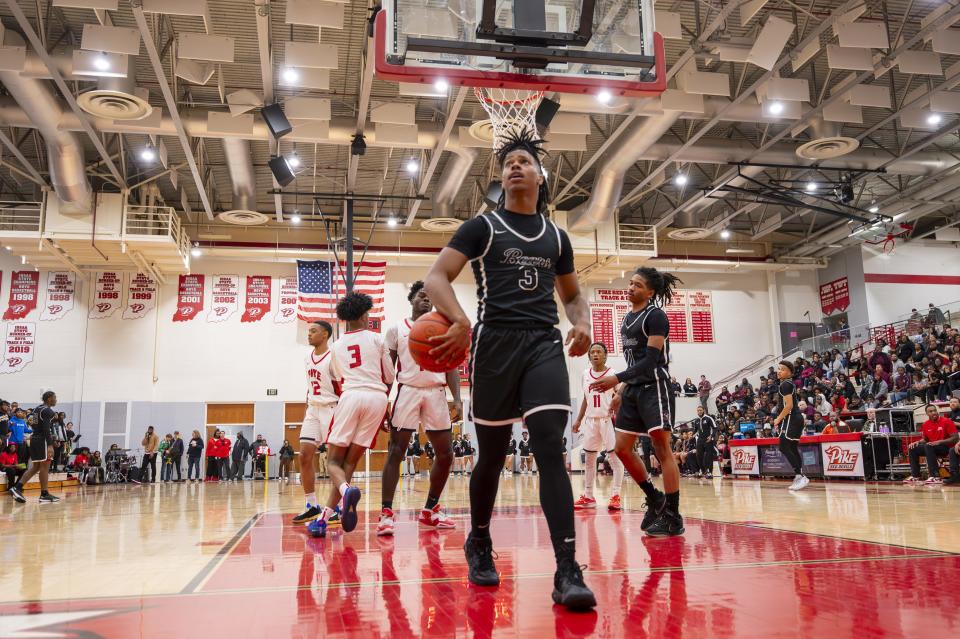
[425,129,596,609]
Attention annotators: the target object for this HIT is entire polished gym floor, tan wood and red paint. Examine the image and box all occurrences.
[0,475,960,639]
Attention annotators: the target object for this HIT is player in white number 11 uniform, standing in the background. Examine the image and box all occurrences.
[573,342,623,510]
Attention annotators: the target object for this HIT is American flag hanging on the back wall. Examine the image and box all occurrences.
[297,260,387,324]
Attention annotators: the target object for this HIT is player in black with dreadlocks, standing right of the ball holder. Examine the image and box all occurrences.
[590,267,684,537]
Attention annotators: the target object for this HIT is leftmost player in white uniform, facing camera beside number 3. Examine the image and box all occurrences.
[293,321,340,524]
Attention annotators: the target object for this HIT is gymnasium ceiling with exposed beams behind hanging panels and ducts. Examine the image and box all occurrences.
[0,0,960,257]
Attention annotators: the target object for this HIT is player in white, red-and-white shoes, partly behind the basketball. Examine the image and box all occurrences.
[377,282,463,536]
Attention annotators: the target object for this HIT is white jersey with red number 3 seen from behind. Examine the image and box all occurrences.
[330,330,395,393]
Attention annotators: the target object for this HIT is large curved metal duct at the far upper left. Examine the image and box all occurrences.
[0,30,92,213]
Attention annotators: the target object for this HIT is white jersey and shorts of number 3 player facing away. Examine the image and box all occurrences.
[327,330,395,448]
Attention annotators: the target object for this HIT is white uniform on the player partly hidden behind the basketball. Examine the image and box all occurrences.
[384,319,451,431]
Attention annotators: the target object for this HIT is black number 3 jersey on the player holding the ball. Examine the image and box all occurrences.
[450,211,573,327]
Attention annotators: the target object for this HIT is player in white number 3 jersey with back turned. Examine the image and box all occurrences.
[309,293,395,537]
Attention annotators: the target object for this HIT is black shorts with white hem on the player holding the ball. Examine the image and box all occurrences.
[470,324,571,426]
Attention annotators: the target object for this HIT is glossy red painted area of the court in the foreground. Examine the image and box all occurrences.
[0,507,960,638]
